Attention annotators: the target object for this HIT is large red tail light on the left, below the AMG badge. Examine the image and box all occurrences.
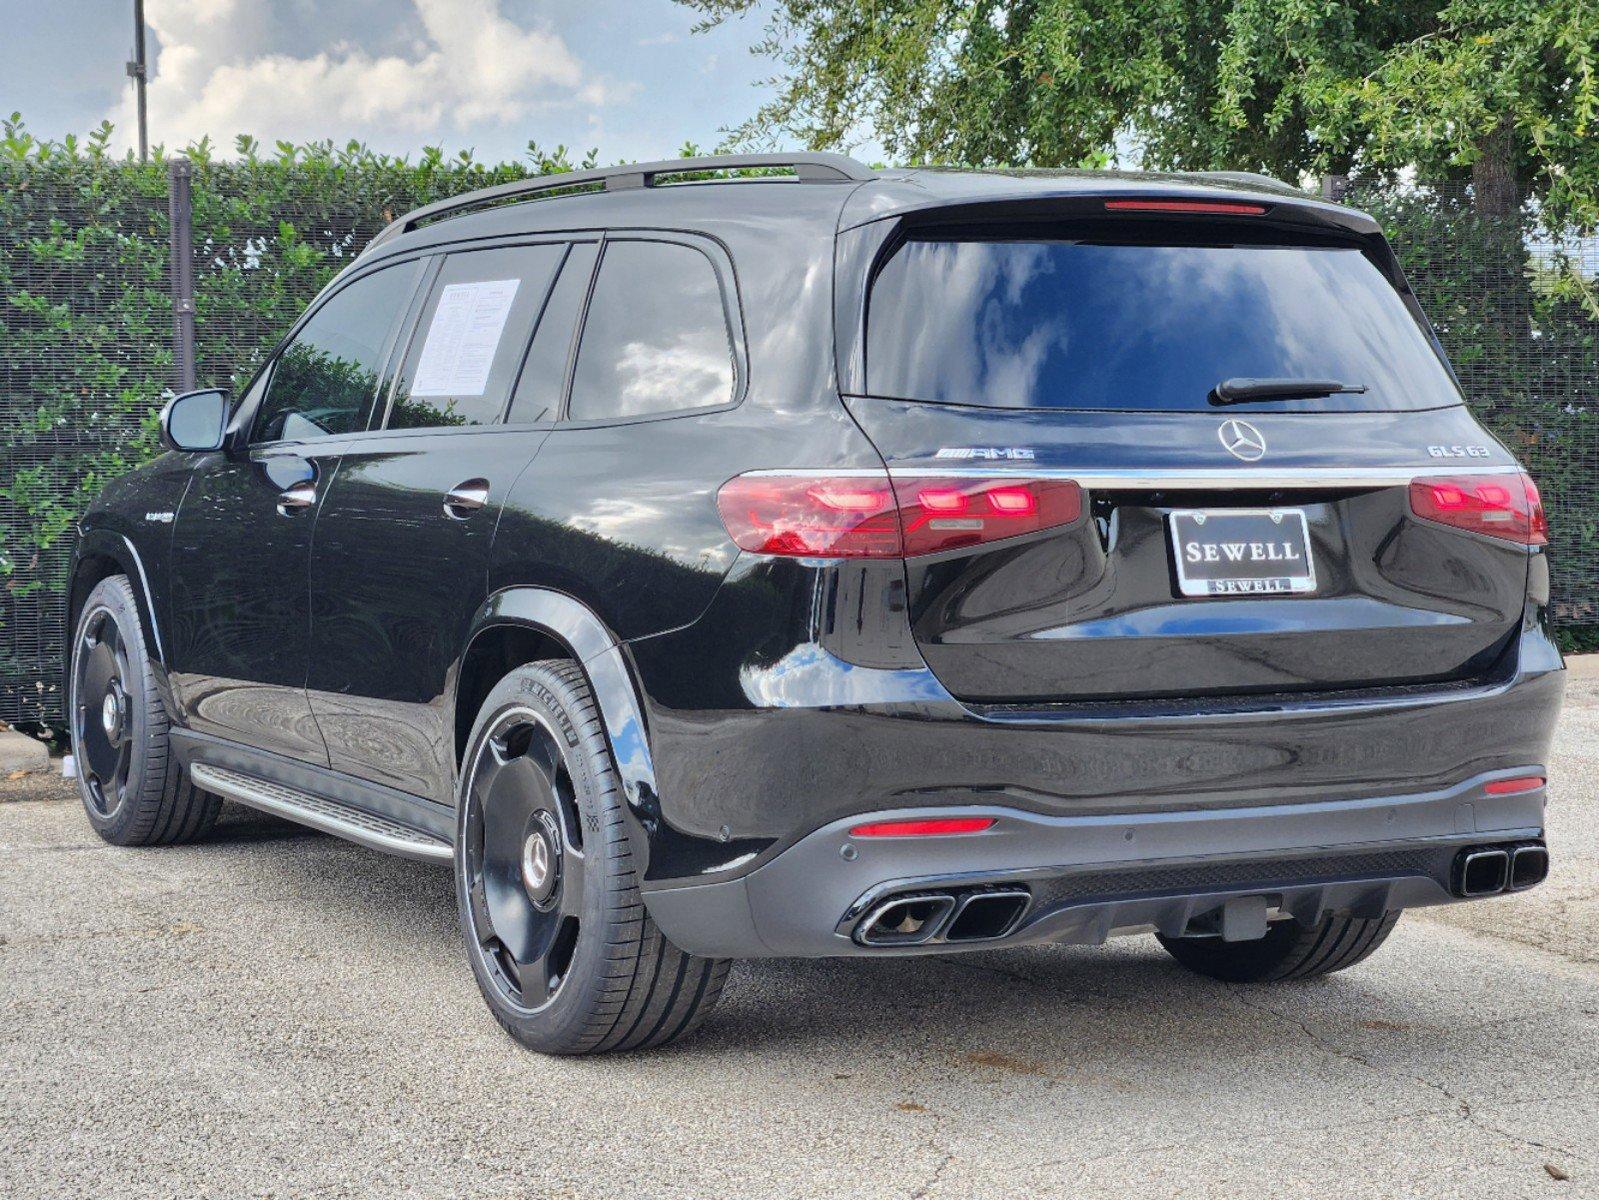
[716,474,1083,558]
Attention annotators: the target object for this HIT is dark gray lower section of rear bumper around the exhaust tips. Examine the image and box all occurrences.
[646,768,1545,957]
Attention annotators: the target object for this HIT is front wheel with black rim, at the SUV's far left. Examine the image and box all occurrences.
[67,574,222,846]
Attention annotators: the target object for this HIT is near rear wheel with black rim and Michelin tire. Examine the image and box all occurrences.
[456,659,728,1054]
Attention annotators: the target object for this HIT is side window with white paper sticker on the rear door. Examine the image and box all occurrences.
[387,243,566,429]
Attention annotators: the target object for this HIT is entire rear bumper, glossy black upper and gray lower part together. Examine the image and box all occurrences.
[616,560,1565,957]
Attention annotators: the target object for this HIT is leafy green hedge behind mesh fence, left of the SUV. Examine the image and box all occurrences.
[0,117,610,722]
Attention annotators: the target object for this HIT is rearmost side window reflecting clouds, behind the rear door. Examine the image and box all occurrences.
[568,242,732,421]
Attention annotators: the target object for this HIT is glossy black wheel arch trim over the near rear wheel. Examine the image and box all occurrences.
[451,587,660,875]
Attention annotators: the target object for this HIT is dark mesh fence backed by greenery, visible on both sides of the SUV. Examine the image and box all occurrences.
[0,157,1599,723]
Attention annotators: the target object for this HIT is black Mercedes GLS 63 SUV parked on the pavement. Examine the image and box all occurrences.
[67,154,1564,1053]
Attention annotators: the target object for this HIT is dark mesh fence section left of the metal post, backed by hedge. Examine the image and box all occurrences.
[0,160,171,723]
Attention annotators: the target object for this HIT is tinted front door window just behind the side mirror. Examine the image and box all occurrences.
[249,262,422,442]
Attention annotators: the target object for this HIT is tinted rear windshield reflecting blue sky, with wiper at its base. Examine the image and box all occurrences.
[867,240,1460,411]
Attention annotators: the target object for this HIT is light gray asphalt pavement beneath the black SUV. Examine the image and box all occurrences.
[0,678,1599,1200]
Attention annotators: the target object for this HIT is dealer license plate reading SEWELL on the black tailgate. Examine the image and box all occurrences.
[1167,509,1316,595]
